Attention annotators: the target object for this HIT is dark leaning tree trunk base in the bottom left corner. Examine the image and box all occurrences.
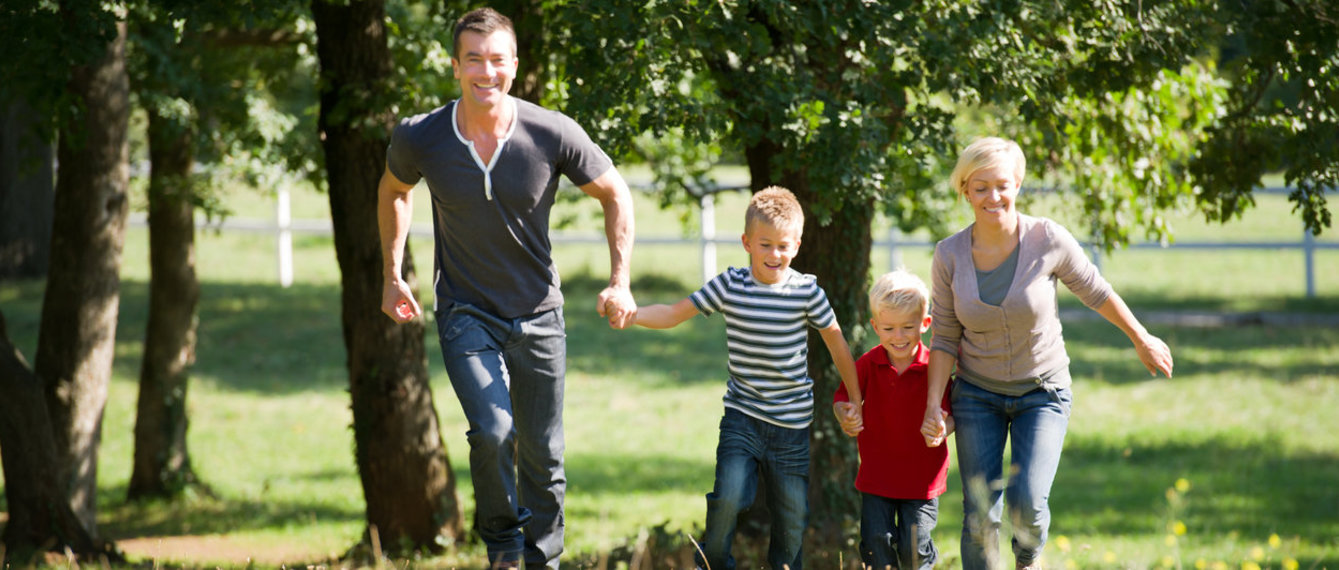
[0,314,123,567]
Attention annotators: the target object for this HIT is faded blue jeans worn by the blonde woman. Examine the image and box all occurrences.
[952,380,1073,570]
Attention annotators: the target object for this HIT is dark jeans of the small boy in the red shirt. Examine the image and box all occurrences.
[860,492,939,570]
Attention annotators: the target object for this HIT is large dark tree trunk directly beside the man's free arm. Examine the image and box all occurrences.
[312,0,463,551]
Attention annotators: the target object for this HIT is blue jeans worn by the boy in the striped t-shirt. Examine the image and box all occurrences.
[698,408,809,570]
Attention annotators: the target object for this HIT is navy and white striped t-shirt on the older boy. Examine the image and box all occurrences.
[688,268,836,430]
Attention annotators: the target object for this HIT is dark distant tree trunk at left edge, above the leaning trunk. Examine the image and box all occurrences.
[0,97,55,280]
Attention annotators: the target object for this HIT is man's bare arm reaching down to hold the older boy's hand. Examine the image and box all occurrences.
[581,167,637,329]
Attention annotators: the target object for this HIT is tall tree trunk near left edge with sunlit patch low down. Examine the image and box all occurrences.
[35,13,130,535]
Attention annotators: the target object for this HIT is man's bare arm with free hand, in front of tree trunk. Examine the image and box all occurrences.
[376,167,423,322]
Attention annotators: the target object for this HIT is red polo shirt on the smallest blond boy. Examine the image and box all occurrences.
[833,344,949,499]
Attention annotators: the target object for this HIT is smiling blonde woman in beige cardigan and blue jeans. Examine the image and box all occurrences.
[921,138,1172,570]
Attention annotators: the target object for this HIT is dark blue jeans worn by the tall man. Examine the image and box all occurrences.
[437,304,568,569]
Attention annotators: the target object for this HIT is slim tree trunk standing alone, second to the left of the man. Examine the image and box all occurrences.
[127,111,200,500]
